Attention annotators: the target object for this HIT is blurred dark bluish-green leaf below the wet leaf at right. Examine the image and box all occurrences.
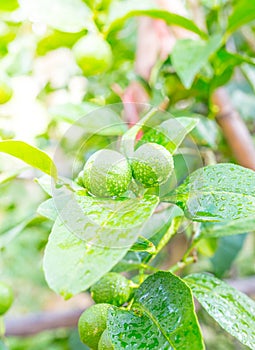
[210,235,246,278]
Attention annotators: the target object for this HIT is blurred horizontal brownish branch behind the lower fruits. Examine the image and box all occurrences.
[5,277,255,337]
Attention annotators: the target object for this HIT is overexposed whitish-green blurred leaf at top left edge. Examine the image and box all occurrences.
[19,0,94,33]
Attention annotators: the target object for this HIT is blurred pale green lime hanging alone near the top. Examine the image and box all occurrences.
[73,34,113,77]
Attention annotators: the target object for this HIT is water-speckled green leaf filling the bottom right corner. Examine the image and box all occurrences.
[185,273,255,349]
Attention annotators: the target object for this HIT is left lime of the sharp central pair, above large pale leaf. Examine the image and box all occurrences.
[83,149,132,197]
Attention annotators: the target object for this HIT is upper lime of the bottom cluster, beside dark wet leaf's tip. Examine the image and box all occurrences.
[91,272,132,306]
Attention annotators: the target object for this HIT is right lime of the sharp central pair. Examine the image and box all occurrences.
[131,143,174,187]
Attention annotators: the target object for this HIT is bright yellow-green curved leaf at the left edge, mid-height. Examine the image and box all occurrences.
[0,140,58,180]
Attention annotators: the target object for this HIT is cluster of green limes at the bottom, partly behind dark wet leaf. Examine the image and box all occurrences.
[78,272,132,350]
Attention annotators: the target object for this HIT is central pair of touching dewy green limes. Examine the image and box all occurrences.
[77,143,174,197]
